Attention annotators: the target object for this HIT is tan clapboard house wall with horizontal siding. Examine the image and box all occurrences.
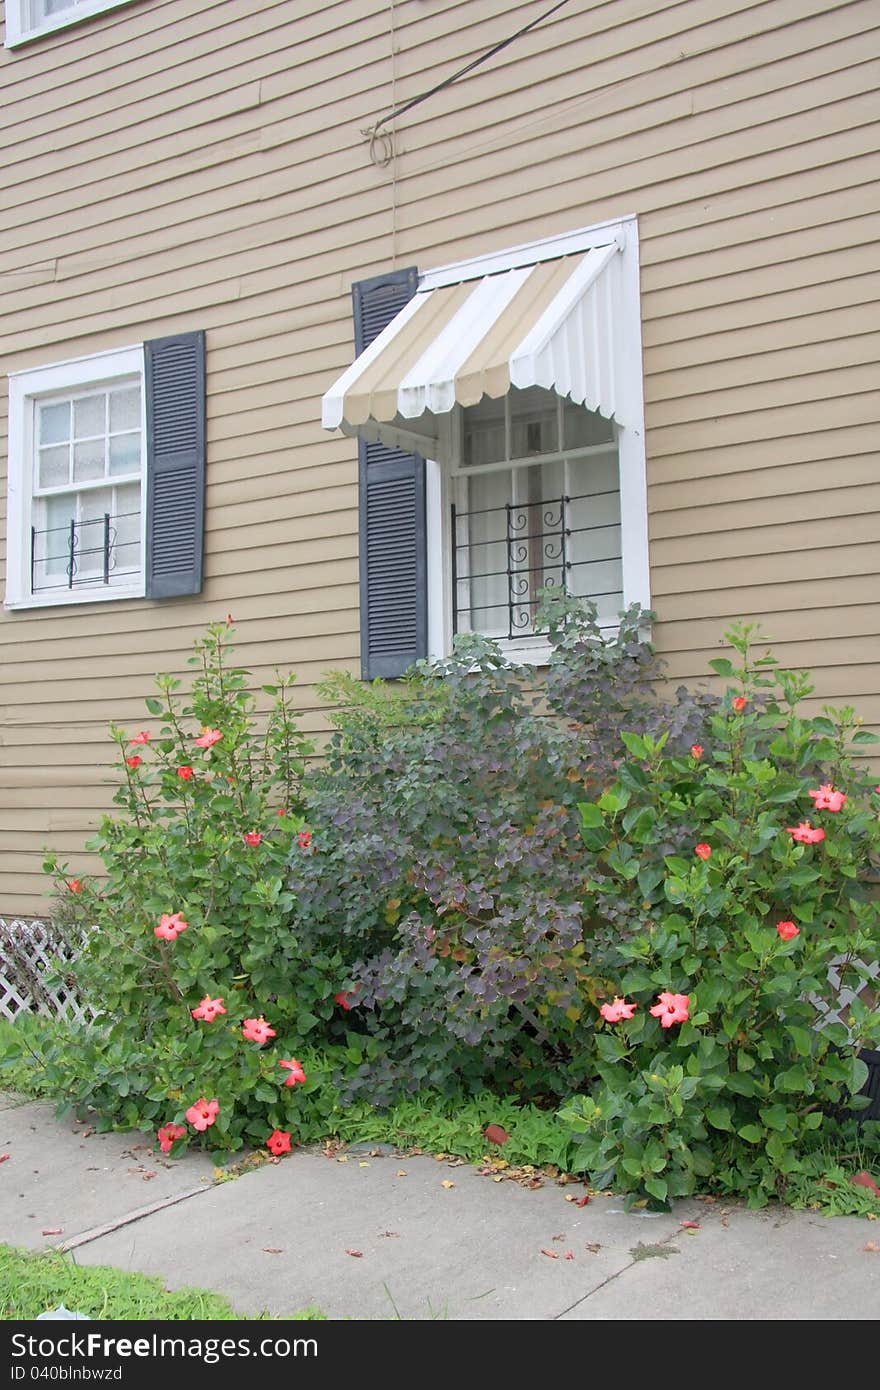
[0,0,880,915]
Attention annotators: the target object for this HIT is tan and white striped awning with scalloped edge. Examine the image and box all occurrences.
[321,238,627,456]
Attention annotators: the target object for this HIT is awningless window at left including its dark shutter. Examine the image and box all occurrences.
[6,334,204,609]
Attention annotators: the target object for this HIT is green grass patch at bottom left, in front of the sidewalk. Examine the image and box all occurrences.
[0,1245,325,1322]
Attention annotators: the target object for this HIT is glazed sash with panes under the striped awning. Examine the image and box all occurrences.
[450,386,623,646]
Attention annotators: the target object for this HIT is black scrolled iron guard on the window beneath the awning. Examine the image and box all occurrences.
[452,489,623,638]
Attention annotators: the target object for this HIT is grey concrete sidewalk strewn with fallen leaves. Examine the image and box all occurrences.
[0,1097,880,1321]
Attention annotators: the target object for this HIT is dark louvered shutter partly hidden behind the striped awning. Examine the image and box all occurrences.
[352,268,428,681]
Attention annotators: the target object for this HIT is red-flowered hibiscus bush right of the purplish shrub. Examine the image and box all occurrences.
[562,627,880,1205]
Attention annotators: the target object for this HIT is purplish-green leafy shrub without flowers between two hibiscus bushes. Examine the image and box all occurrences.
[288,598,705,1104]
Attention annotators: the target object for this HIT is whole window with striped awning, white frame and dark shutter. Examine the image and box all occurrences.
[328,217,651,678]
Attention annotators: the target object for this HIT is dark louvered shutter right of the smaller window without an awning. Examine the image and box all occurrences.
[143,332,204,599]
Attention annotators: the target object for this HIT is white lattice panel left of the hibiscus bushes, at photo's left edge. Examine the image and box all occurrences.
[0,917,92,1023]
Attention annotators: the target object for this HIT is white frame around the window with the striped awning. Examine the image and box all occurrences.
[420,215,651,666]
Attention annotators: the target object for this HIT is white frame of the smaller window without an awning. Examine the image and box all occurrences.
[4,343,147,609]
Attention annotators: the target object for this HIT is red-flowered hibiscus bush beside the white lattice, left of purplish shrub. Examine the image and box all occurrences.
[37,624,353,1152]
